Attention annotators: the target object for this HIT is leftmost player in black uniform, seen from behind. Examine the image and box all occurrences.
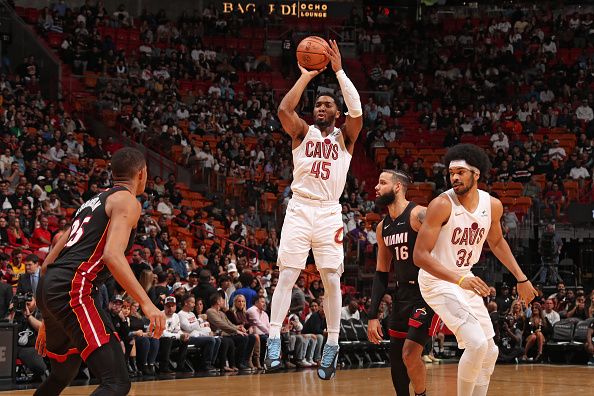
[35,148,165,396]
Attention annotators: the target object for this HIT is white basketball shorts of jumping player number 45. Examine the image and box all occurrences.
[278,195,344,274]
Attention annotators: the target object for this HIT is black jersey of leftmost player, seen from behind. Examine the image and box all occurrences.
[51,186,136,286]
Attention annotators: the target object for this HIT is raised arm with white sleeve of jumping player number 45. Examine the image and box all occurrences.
[326,40,363,154]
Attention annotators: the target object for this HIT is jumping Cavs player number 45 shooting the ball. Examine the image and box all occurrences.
[265,41,363,380]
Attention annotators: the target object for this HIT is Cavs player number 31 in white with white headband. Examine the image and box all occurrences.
[413,144,537,396]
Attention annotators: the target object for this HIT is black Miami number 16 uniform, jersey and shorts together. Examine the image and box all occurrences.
[382,202,439,345]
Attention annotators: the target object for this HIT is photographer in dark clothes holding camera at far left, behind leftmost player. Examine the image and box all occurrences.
[8,293,47,379]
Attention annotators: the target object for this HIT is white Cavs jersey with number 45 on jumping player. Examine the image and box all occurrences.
[291,125,352,202]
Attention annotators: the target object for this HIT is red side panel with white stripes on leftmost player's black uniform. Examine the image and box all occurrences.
[69,222,110,361]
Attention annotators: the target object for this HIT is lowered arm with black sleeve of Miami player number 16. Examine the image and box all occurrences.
[367,221,392,344]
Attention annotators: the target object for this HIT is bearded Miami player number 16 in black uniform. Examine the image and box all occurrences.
[368,170,438,396]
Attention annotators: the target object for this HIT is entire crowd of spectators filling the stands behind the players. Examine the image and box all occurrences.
[0,2,594,384]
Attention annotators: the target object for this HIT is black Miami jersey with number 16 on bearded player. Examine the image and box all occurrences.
[382,202,419,284]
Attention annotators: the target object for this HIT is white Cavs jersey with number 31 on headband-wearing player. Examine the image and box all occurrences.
[419,189,491,280]
